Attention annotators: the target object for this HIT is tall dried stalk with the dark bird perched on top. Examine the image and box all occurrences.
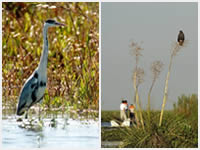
[159,43,182,126]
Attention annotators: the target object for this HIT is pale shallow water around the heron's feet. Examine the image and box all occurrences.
[2,117,99,149]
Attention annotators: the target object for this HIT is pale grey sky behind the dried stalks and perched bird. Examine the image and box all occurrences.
[101,2,198,110]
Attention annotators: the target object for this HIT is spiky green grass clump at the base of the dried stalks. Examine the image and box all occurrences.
[121,111,198,148]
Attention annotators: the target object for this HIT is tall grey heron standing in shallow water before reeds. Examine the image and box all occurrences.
[17,19,64,116]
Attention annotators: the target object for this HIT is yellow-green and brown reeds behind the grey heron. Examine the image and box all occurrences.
[2,2,99,113]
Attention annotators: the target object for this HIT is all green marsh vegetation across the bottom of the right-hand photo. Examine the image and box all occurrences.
[101,94,198,148]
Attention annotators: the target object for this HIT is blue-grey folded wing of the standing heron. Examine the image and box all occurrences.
[17,73,38,111]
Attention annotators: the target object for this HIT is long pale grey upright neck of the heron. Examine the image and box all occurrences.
[39,26,48,73]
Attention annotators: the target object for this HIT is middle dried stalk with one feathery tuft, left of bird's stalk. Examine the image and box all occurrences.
[147,61,163,121]
